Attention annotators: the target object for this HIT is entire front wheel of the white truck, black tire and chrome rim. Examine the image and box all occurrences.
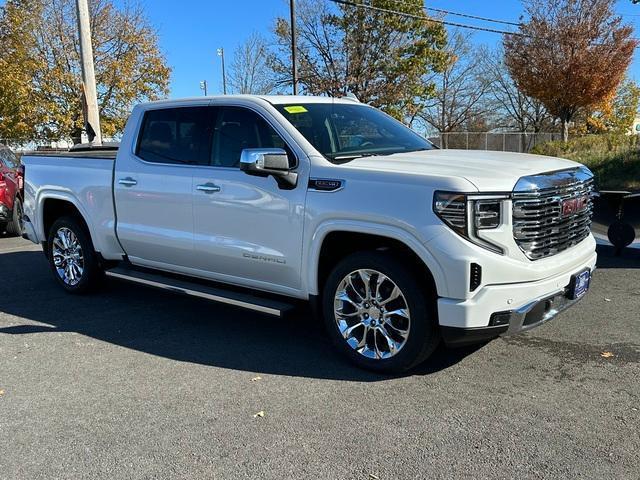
[322,251,440,373]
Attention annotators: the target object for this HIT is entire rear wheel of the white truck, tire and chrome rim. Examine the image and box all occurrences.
[47,217,102,294]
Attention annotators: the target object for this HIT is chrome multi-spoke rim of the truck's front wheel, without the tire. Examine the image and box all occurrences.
[334,269,411,360]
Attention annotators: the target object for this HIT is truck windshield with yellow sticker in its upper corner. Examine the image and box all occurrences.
[275,103,434,163]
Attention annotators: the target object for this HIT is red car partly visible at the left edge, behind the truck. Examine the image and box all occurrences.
[0,145,24,235]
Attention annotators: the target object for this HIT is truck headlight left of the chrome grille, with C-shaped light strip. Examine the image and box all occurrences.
[433,192,509,255]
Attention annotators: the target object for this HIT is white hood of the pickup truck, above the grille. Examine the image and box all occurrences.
[345,150,579,192]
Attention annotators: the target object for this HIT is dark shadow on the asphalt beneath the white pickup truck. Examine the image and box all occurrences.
[0,252,481,382]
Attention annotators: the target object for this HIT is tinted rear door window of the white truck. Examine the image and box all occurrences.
[136,107,213,165]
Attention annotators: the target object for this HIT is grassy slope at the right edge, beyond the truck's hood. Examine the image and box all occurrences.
[531,135,640,190]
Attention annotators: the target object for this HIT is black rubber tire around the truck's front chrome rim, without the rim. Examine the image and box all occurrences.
[322,251,438,373]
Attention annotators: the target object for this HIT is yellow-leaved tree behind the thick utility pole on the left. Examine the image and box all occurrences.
[0,0,170,142]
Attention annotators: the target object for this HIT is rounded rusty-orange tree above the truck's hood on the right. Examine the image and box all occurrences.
[503,0,638,141]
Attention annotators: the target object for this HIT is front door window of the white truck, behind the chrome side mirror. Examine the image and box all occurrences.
[211,107,293,168]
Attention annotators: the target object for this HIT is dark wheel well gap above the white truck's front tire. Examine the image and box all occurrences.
[318,231,437,298]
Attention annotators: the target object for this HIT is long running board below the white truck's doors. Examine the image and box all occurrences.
[105,267,293,317]
